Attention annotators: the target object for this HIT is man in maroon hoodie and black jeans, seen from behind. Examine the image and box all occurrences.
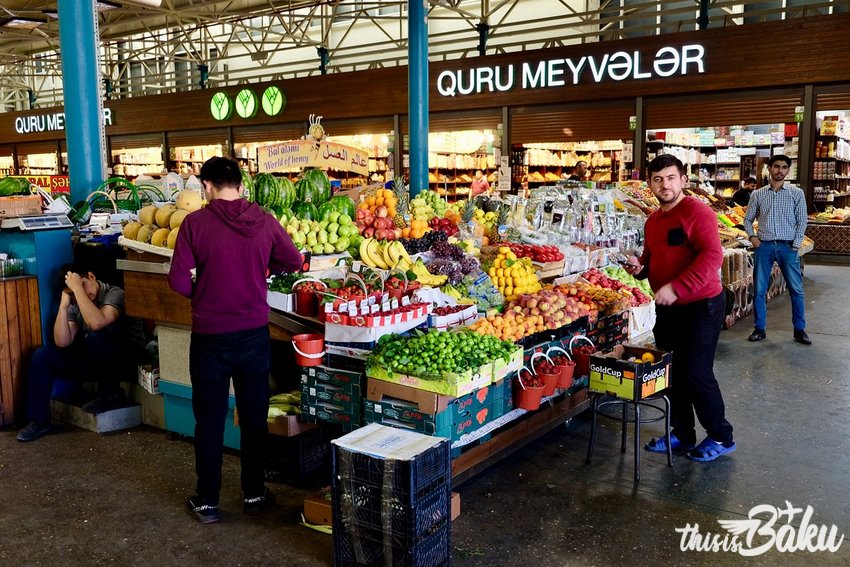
[168,157,301,524]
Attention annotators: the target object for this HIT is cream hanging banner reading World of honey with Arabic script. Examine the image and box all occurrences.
[257,140,369,175]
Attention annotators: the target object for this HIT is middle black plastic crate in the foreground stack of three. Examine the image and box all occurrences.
[332,484,451,548]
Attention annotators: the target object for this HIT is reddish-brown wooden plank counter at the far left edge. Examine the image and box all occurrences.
[0,276,42,427]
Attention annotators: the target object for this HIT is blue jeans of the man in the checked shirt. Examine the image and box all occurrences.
[753,241,806,331]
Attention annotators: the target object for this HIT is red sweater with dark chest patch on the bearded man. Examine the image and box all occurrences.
[641,196,723,304]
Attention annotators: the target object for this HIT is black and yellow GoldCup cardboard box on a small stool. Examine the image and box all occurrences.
[589,344,673,400]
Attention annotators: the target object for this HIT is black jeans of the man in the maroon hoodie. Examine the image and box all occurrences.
[189,326,271,504]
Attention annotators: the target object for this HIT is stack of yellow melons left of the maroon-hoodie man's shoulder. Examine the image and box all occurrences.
[122,189,203,249]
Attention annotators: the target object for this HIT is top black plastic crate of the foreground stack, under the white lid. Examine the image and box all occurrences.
[331,439,452,506]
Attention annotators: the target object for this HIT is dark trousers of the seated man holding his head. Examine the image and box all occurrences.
[27,325,129,421]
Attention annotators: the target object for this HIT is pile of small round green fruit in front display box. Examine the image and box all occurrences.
[367,329,516,378]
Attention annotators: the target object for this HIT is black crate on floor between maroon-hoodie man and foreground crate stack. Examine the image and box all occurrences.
[266,428,330,486]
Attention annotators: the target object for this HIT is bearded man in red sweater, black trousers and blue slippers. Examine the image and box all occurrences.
[626,155,735,462]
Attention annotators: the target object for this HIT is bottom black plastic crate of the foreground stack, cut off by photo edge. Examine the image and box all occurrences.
[333,524,452,567]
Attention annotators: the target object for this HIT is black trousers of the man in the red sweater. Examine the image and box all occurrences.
[653,292,732,445]
